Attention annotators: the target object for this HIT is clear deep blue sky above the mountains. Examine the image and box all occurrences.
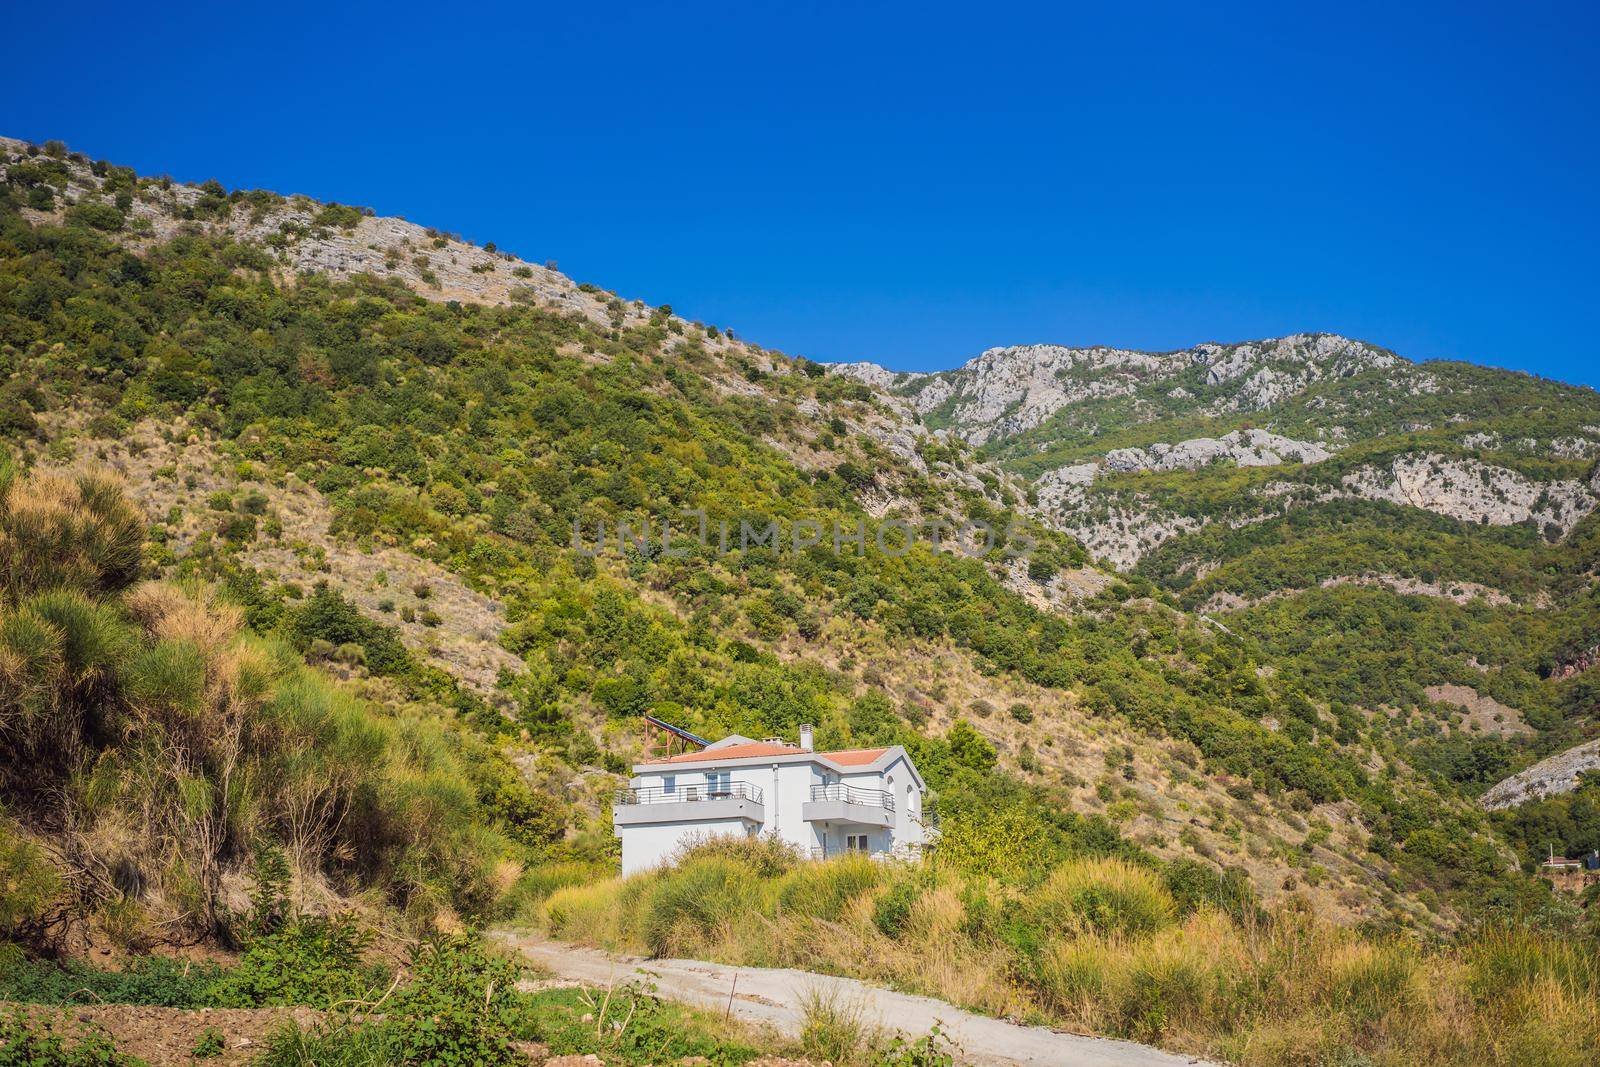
[0,0,1600,384]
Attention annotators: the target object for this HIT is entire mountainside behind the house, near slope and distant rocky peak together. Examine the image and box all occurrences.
[0,127,1600,959]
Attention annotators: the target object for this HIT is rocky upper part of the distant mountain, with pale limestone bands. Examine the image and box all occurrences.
[835,334,1600,569]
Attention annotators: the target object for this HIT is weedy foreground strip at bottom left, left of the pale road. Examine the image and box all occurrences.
[0,918,800,1067]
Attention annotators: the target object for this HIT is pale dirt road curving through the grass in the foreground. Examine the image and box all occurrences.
[499,933,1214,1067]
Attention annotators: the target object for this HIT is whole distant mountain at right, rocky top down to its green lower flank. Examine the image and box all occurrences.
[835,334,1600,862]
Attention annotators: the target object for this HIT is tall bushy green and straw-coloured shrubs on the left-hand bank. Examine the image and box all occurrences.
[0,469,517,941]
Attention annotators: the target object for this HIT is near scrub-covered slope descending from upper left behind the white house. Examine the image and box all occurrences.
[0,133,1565,925]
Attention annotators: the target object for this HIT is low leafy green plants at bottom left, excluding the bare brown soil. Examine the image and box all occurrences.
[0,937,770,1067]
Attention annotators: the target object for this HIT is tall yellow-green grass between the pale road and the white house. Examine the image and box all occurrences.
[542,843,1600,1067]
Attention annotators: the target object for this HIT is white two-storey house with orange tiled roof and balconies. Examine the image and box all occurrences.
[611,726,930,875]
